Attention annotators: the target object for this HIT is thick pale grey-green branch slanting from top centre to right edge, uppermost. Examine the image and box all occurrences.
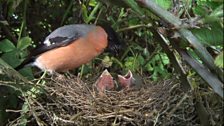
[137,0,224,81]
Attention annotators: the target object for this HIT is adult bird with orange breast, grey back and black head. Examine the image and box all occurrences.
[16,24,121,73]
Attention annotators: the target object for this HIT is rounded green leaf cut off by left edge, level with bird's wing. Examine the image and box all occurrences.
[0,39,16,52]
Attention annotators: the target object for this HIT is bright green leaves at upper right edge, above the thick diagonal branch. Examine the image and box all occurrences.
[192,2,223,46]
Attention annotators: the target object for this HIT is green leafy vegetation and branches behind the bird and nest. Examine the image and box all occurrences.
[0,0,223,125]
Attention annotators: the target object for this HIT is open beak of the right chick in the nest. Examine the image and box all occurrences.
[118,70,135,88]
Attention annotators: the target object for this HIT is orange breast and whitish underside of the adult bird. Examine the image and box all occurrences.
[36,27,108,72]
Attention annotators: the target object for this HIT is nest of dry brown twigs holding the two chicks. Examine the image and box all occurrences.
[19,76,201,126]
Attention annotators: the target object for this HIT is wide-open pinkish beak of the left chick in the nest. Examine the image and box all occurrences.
[96,69,114,92]
